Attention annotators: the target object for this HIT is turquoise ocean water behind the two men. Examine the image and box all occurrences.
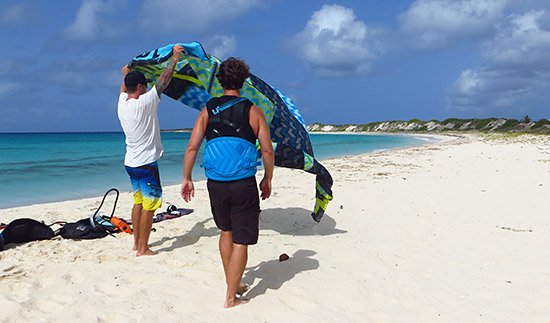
[0,132,432,209]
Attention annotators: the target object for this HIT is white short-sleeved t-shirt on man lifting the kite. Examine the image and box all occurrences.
[118,86,164,167]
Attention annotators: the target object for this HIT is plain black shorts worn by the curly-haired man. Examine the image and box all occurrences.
[207,176,260,245]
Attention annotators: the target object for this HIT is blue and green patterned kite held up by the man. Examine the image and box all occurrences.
[128,42,332,222]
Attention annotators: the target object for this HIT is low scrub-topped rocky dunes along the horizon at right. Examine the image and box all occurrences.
[308,116,550,134]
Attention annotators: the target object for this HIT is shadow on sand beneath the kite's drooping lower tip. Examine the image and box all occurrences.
[260,208,347,236]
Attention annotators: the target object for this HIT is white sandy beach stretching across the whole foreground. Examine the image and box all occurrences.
[0,136,550,322]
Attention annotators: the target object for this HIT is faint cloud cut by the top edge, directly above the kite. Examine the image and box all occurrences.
[140,0,262,33]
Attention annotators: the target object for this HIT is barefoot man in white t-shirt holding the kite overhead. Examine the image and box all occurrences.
[118,45,183,256]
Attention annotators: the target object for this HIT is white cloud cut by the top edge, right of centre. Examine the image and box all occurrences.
[399,0,510,49]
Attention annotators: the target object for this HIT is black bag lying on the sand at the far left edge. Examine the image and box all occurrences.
[0,218,54,250]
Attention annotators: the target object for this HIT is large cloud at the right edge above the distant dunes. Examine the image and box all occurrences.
[447,11,550,111]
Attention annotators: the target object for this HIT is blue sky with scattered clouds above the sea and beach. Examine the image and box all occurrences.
[0,0,550,132]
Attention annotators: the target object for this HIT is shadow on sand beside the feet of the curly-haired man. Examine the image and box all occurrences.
[242,249,319,299]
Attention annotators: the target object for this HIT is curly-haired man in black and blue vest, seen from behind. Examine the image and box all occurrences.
[181,57,274,308]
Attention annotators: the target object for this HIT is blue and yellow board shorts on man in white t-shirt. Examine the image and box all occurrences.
[125,161,162,211]
